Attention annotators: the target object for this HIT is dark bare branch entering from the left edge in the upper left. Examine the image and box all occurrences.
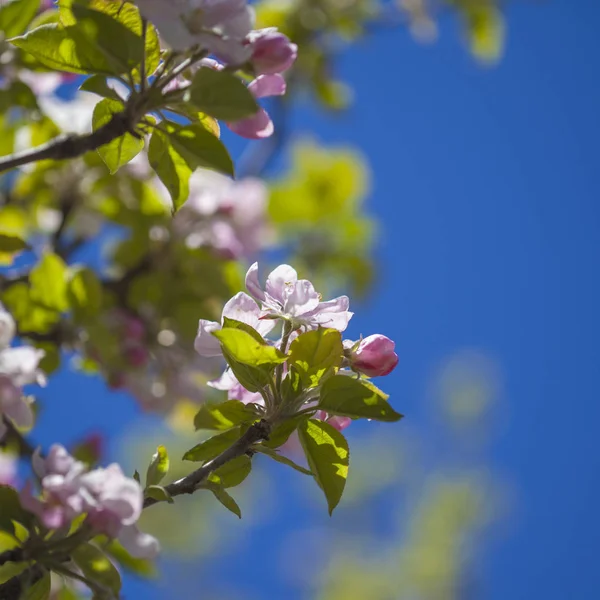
[0,110,136,173]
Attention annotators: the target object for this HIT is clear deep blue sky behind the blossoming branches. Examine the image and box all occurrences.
[27,0,600,600]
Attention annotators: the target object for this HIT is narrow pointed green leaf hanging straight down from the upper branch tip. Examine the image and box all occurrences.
[148,129,192,213]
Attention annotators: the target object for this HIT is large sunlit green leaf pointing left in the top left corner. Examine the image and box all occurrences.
[10,23,115,75]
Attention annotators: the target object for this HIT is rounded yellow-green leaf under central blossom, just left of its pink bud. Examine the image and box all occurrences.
[289,327,344,387]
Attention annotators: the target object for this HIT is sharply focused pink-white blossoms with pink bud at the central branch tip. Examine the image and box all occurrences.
[194,263,398,430]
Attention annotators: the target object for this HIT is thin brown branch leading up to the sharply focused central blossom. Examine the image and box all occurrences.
[144,419,271,508]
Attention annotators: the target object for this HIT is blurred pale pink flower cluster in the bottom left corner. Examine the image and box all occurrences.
[21,444,159,558]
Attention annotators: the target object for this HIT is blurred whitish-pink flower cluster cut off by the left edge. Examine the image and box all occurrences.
[0,305,45,439]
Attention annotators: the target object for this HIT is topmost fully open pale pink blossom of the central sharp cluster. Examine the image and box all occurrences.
[246,263,353,331]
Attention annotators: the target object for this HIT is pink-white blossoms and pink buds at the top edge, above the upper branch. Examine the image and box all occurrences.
[136,0,298,139]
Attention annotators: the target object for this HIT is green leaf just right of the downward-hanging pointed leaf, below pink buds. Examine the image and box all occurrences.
[168,123,234,177]
